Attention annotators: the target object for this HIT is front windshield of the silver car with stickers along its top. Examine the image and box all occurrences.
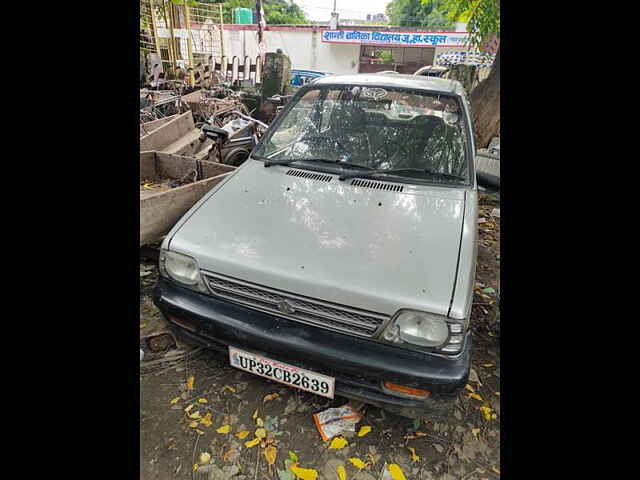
[254,86,468,184]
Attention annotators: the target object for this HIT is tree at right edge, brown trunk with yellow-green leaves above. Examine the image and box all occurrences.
[445,0,500,148]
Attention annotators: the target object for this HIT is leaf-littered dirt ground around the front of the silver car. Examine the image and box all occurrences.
[140,195,500,480]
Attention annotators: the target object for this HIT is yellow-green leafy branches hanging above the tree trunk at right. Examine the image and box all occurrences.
[444,0,500,46]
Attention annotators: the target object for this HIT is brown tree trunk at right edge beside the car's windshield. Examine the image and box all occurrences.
[469,48,500,148]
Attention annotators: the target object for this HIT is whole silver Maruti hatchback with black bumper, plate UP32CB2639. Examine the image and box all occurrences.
[154,74,478,418]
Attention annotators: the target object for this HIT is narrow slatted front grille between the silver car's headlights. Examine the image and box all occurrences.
[202,272,389,337]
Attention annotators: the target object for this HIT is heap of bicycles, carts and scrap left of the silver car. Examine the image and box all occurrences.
[140,82,294,248]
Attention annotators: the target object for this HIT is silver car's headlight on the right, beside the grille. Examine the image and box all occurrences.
[382,310,464,353]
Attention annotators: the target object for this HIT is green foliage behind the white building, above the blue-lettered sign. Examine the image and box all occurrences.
[386,0,455,30]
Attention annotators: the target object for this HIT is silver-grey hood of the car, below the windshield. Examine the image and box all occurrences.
[169,160,465,315]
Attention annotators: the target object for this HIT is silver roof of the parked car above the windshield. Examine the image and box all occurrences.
[313,73,464,96]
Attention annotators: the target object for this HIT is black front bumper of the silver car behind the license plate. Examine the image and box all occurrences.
[153,278,471,418]
